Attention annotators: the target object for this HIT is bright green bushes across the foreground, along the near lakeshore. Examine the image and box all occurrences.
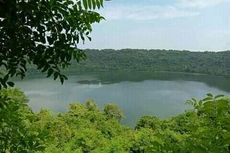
[0,89,230,153]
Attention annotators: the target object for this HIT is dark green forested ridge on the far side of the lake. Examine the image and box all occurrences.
[66,49,230,75]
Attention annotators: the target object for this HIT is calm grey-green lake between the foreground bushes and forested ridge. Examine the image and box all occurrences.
[16,72,230,126]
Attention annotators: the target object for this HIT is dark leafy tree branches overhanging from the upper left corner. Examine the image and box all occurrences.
[0,0,103,88]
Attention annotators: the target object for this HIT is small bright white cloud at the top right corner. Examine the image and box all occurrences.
[177,0,230,9]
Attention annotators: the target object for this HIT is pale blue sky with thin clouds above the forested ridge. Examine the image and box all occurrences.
[81,0,230,51]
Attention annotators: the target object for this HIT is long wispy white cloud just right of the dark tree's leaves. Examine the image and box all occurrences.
[102,5,199,20]
